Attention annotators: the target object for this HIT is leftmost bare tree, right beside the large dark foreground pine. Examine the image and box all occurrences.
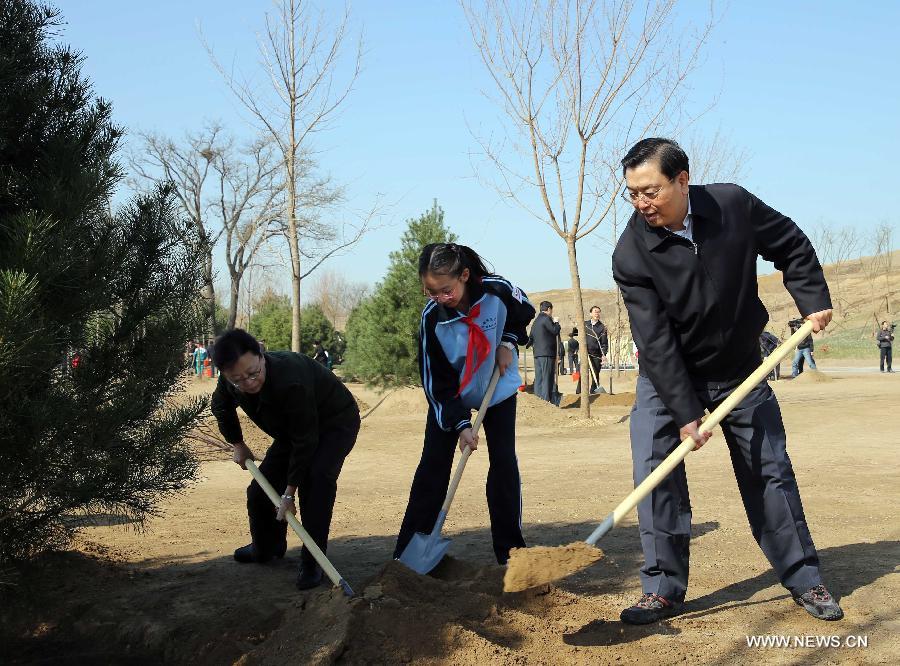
[128,123,224,335]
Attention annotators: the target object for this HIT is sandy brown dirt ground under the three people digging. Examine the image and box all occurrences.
[7,366,900,664]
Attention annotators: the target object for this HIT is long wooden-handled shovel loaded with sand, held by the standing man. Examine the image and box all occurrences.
[503,321,813,592]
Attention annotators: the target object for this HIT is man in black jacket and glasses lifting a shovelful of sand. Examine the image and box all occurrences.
[613,139,843,624]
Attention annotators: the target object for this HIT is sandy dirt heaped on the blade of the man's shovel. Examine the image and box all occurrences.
[503,541,603,592]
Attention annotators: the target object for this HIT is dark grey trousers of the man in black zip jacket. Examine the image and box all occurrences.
[631,376,822,601]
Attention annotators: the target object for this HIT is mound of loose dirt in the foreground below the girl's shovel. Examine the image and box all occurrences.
[237,558,596,665]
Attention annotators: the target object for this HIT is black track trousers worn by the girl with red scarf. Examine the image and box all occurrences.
[394,392,528,564]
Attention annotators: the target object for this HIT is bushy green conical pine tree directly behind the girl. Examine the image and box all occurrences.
[345,203,456,386]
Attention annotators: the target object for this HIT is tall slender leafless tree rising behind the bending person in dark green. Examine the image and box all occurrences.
[206,0,371,351]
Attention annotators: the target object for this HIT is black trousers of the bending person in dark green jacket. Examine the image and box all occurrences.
[247,412,359,566]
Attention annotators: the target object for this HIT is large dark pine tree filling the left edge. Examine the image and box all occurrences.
[0,0,204,564]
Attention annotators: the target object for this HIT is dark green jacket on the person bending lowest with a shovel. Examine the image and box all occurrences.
[212,351,359,485]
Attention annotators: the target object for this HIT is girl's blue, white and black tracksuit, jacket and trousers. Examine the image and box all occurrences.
[394,275,534,564]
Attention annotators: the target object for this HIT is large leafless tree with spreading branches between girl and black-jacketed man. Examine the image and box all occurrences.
[461,0,712,417]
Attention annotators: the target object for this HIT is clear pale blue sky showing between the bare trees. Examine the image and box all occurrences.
[58,0,900,291]
